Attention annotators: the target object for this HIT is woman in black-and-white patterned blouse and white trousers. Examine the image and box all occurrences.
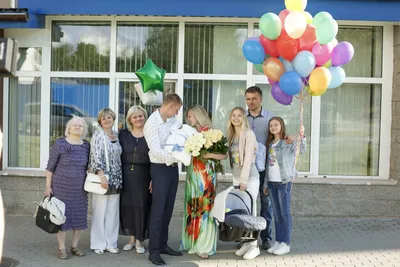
[90,108,122,254]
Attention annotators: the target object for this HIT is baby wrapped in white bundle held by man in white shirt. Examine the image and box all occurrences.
[164,122,197,166]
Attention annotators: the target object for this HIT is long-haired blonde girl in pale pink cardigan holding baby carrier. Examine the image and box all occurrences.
[228,107,260,260]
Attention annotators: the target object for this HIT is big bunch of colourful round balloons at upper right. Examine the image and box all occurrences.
[242,0,354,105]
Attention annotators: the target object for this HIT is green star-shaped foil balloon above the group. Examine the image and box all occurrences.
[135,58,166,93]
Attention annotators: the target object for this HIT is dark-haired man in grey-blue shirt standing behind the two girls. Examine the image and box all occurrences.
[245,86,275,250]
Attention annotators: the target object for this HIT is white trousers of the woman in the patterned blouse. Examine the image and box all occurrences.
[90,194,119,250]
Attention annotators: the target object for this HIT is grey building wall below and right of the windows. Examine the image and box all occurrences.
[0,26,400,217]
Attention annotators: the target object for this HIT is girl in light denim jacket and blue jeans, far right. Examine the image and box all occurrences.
[264,117,307,255]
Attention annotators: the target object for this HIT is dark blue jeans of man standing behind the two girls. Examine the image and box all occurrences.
[259,171,272,243]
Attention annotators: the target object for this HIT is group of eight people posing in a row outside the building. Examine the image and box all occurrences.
[45,86,306,265]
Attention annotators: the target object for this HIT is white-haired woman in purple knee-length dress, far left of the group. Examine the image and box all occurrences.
[45,117,90,259]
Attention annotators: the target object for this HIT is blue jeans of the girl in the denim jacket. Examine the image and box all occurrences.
[268,182,292,245]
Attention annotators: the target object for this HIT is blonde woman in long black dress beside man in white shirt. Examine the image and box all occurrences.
[119,106,151,254]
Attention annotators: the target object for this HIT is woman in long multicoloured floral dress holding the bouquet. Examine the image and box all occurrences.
[180,105,227,259]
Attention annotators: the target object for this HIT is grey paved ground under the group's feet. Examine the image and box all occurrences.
[0,215,400,267]
